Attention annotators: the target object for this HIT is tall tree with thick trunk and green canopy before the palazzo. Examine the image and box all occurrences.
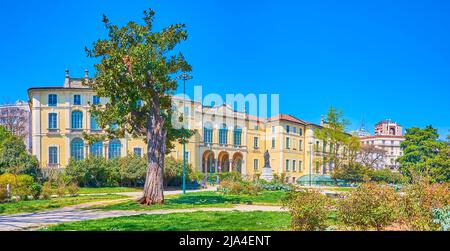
[86,9,192,205]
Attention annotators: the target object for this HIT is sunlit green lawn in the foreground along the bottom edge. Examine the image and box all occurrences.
[42,211,291,231]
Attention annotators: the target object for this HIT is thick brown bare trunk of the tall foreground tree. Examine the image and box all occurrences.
[139,101,167,205]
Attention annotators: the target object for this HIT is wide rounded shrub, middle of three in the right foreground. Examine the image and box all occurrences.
[337,183,400,231]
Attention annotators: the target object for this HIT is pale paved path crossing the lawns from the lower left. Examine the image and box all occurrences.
[0,188,284,231]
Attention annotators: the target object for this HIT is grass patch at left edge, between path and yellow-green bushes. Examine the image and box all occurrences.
[0,194,127,215]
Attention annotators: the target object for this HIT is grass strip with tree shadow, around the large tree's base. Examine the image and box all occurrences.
[90,191,285,211]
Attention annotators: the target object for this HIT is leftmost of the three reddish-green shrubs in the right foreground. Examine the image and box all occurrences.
[283,189,331,231]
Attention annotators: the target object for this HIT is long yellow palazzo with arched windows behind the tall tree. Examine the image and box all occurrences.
[28,71,330,182]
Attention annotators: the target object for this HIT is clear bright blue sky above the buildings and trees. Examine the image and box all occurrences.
[0,0,450,138]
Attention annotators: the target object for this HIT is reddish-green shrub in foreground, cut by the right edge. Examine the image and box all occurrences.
[402,179,450,231]
